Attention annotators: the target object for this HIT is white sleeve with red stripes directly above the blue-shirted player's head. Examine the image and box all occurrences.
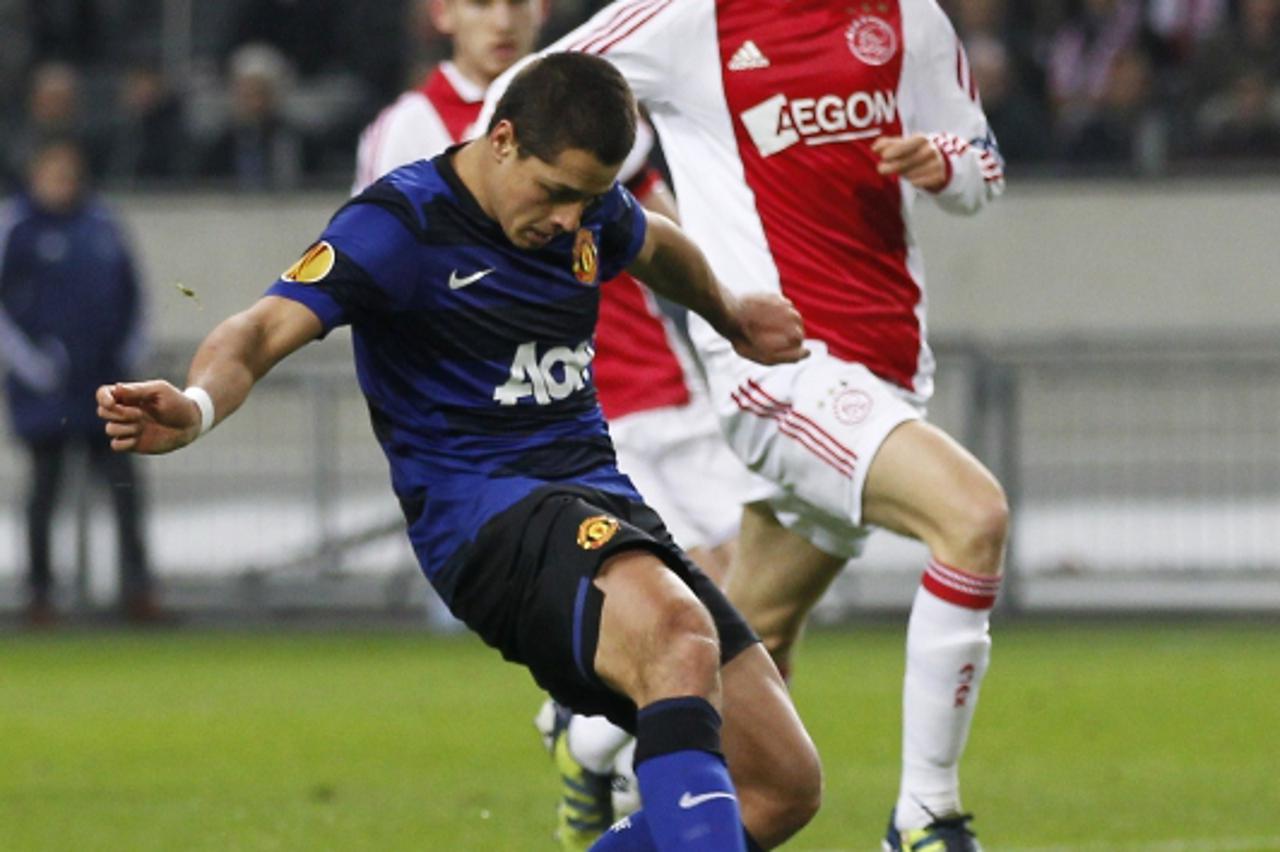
[476,0,714,128]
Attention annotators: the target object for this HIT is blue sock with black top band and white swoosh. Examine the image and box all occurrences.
[635,696,746,852]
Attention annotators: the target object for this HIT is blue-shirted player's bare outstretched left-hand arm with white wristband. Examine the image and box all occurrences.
[97,296,324,454]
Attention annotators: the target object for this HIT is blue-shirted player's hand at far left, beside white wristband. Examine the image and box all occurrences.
[96,379,200,454]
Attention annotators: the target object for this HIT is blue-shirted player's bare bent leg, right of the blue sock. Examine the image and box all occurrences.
[721,645,822,846]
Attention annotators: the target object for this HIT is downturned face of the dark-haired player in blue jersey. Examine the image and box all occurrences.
[489,122,620,248]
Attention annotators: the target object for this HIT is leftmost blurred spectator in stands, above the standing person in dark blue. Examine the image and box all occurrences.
[8,61,106,182]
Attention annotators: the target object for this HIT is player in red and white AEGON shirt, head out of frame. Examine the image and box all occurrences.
[490,0,1007,852]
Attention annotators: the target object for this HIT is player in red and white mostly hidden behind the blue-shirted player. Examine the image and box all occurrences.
[352,0,753,852]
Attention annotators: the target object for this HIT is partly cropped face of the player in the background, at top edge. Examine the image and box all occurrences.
[435,0,544,86]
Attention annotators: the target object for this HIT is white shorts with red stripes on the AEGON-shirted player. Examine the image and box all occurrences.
[703,340,924,558]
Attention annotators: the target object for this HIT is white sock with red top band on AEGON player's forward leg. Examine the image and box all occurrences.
[895,560,1000,829]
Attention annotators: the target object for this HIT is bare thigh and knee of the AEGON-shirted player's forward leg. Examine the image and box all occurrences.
[863,421,1007,542]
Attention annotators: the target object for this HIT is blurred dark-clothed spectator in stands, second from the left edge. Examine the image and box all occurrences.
[108,64,189,182]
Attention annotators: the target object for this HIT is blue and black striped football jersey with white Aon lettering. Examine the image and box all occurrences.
[268,151,645,600]
